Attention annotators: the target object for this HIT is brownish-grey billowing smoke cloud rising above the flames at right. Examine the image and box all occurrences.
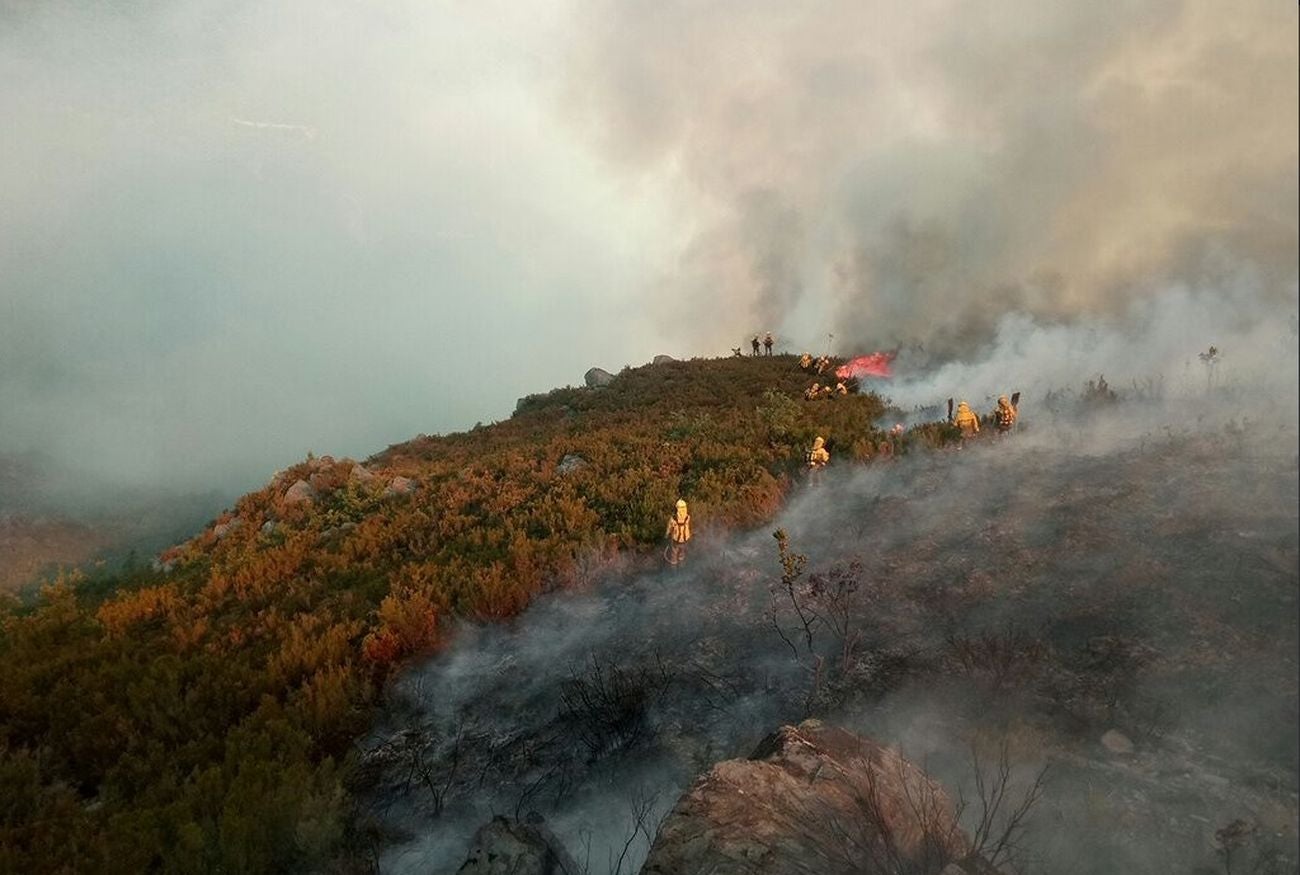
[571,0,1300,360]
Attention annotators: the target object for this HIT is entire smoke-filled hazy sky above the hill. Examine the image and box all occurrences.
[0,0,1297,490]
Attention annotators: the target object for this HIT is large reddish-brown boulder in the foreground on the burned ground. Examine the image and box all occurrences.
[641,720,980,875]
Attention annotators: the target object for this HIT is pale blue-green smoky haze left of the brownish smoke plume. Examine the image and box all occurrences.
[0,0,684,491]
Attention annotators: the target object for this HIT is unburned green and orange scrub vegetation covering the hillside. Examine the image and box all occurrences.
[0,356,953,872]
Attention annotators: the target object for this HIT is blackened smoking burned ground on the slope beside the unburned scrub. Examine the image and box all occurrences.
[365,407,1300,872]
